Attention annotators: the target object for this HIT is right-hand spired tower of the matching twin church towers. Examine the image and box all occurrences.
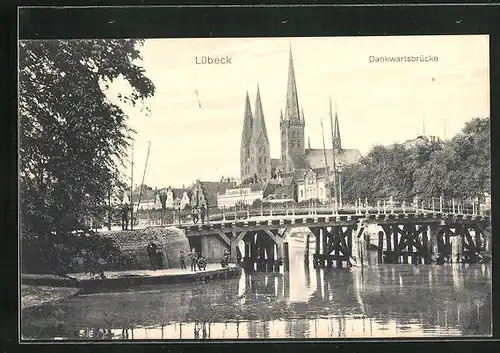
[250,85,271,181]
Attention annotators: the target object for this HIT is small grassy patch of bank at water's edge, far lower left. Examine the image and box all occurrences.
[21,284,79,310]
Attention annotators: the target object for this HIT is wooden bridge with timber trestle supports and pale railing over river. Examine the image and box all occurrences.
[166,202,490,271]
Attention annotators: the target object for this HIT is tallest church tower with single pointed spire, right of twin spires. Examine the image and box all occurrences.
[280,46,305,172]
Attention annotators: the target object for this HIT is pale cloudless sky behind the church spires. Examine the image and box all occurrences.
[106,35,490,188]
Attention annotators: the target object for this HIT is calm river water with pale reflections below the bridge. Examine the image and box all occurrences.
[21,242,492,340]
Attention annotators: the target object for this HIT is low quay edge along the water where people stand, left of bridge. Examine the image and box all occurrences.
[21,264,241,292]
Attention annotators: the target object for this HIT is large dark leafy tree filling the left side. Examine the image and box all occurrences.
[19,40,155,274]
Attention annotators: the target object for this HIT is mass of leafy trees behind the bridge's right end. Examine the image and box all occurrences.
[342,118,491,202]
